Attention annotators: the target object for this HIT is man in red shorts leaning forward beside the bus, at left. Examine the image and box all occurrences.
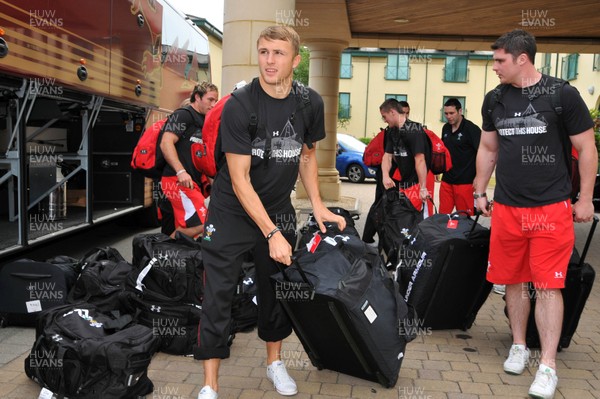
[160,82,219,237]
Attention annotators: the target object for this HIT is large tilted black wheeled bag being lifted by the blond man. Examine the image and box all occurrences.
[272,232,416,388]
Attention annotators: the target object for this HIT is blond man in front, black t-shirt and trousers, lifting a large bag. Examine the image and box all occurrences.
[195,26,345,399]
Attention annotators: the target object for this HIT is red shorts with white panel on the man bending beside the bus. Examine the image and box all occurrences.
[160,176,206,228]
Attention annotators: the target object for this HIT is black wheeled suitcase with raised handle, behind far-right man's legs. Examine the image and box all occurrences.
[526,216,598,351]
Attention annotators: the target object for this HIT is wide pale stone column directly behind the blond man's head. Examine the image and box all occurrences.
[219,0,296,95]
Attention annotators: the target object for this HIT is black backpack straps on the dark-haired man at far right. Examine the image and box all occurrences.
[487,75,580,202]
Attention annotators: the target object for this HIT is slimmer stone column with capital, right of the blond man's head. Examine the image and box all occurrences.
[296,39,348,201]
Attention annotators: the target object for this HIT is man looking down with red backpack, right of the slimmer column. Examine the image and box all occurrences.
[379,98,431,211]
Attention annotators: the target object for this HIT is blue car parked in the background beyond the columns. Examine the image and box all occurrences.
[335,133,375,183]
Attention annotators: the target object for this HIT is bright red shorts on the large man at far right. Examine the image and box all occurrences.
[487,201,575,289]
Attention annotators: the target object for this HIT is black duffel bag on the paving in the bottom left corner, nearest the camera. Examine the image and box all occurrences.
[25,303,159,399]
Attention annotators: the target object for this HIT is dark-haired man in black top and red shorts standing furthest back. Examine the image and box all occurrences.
[440,98,481,215]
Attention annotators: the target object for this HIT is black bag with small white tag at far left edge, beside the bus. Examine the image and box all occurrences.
[0,257,77,326]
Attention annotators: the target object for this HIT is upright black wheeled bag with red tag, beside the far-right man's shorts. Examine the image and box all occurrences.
[396,213,492,330]
